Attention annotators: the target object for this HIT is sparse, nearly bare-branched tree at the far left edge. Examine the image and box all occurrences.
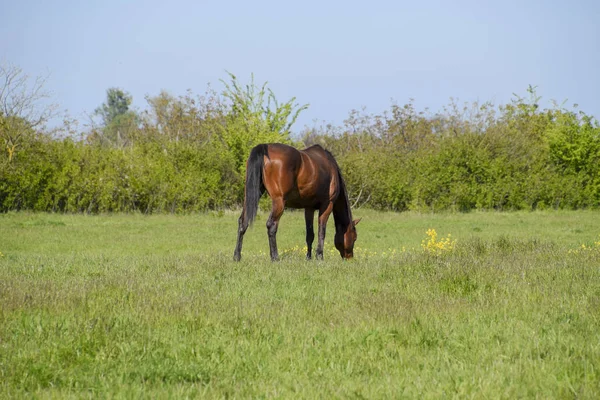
[0,64,57,162]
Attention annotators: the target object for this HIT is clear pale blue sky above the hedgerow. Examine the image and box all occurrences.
[0,0,600,131]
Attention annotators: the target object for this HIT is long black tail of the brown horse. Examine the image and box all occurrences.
[244,144,269,225]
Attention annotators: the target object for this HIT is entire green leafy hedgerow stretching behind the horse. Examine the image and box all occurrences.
[0,74,600,213]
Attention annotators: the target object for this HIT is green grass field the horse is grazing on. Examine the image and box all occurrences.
[0,210,600,399]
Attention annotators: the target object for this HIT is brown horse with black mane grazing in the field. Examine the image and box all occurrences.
[233,143,360,261]
